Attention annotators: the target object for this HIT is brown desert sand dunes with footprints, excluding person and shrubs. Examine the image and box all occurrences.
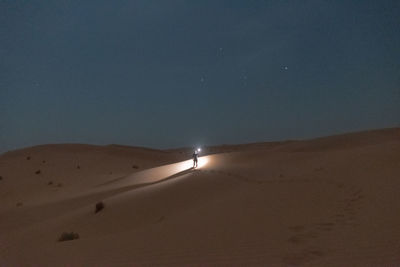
[0,129,400,266]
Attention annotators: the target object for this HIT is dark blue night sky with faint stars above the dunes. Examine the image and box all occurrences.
[0,0,400,152]
